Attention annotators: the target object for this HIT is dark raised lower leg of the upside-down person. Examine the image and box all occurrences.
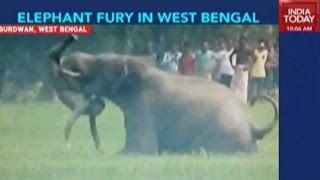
[49,35,78,65]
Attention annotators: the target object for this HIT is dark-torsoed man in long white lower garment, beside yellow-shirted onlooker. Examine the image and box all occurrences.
[229,36,253,102]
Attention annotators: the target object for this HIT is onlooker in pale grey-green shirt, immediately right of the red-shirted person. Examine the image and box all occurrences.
[196,41,218,80]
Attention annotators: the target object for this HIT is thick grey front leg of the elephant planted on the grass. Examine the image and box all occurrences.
[122,108,159,155]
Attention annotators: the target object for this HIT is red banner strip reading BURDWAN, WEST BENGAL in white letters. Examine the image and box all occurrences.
[0,25,91,35]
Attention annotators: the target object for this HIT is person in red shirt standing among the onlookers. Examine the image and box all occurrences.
[179,43,196,76]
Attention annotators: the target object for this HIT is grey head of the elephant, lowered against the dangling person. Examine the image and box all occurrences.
[61,53,148,102]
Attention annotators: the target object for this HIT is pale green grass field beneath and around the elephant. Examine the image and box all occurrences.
[0,102,279,180]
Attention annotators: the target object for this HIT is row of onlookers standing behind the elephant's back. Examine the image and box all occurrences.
[152,36,279,102]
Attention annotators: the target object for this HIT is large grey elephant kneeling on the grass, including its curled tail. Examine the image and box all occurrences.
[53,34,278,155]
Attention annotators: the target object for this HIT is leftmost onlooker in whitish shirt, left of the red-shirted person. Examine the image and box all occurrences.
[162,44,182,73]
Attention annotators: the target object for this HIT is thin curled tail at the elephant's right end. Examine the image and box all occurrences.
[251,95,279,140]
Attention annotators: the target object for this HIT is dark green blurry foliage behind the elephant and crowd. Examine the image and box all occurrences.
[0,25,278,99]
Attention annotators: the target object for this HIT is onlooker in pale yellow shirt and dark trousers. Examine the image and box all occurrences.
[249,40,268,103]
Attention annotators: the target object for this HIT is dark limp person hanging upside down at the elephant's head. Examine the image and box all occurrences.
[48,35,105,152]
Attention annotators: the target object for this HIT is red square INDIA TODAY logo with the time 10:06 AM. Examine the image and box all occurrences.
[279,0,319,32]
